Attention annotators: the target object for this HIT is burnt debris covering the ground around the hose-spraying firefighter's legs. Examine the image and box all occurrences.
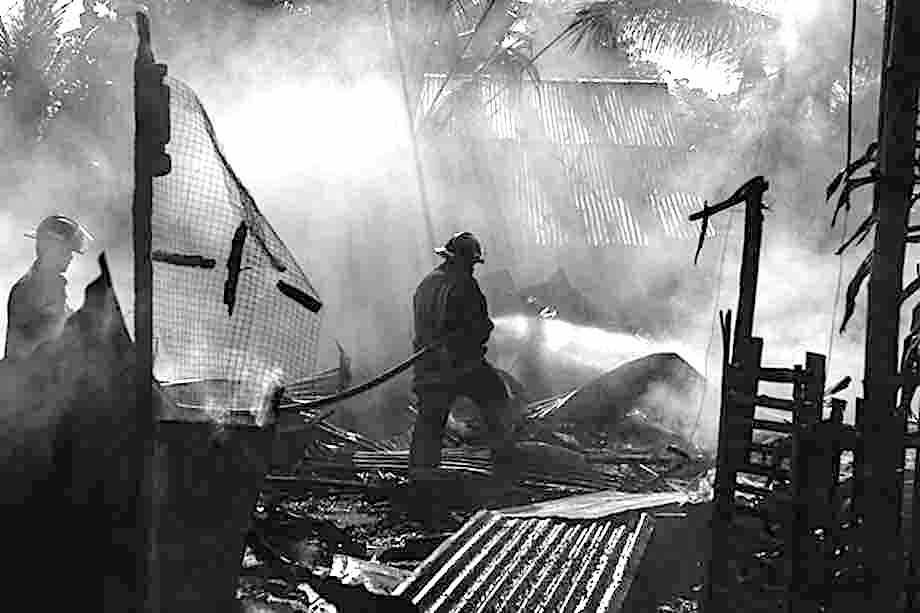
[234,355,744,611]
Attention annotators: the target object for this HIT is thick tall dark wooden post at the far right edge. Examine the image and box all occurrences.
[863,0,920,611]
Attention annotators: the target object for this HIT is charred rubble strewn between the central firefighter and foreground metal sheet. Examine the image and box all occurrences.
[244,352,713,610]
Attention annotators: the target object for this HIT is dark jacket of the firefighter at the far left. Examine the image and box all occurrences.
[5,264,70,360]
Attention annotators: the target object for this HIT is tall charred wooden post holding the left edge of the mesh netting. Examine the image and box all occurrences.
[132,12,170,613]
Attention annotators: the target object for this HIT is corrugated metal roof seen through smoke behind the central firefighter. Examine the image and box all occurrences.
[421,75,711,247]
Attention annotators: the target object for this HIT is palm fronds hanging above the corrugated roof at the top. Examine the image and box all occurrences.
[407,0,778,130]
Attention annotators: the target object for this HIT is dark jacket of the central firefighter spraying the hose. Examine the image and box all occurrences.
[412,262,494,384]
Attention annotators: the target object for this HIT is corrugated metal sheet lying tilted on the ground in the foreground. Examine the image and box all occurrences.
[395,511,653,613]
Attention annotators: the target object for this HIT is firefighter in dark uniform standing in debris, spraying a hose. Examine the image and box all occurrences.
[409,232,514,482]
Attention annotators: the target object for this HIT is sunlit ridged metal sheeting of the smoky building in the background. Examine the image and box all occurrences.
[421,75,699,247]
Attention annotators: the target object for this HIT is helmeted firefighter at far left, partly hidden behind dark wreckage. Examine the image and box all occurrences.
[5,215,93,360]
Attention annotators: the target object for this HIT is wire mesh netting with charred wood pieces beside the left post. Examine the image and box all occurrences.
[152,78,320,401]
